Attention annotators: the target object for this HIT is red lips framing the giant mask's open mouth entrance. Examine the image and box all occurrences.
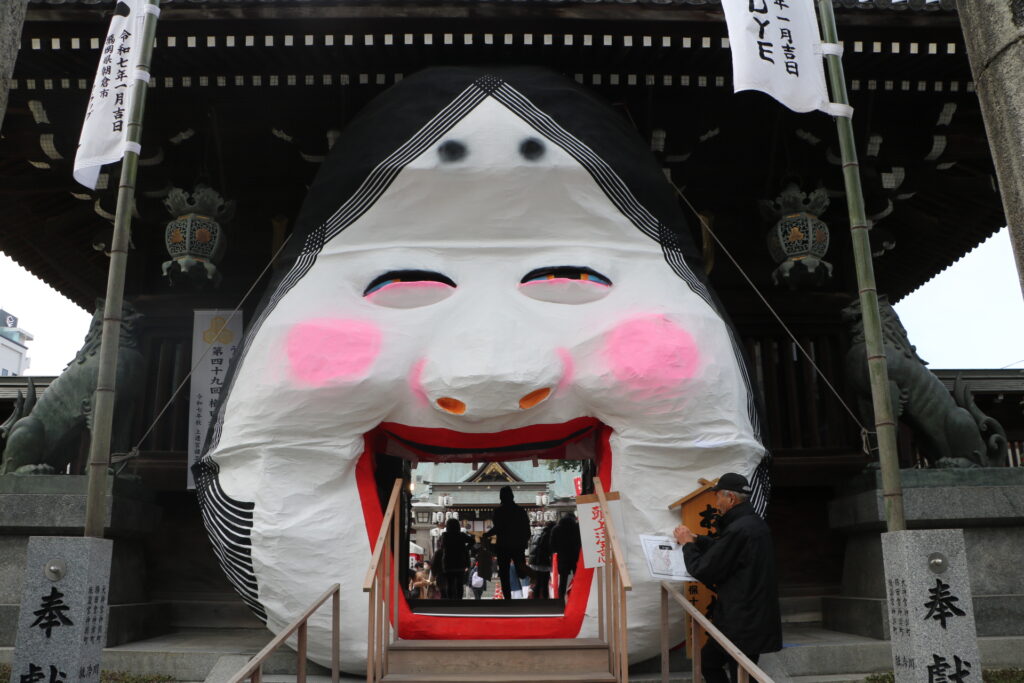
[356,418,611,639]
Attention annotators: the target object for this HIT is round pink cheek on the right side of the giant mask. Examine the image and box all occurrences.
[604,315,700,390]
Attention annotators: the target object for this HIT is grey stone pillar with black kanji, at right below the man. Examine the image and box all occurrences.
[882,529,981,683]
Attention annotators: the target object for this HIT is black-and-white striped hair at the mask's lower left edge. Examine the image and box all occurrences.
[194,457,266,622]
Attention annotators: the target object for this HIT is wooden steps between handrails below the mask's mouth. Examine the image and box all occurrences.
[383,638,615,683]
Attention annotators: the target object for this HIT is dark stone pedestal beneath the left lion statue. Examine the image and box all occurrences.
[0,474,167,646]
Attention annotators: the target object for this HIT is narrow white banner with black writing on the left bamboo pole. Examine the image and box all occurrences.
[74,0,148,189]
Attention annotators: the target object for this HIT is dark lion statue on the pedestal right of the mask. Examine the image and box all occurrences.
[843,296,1007,467]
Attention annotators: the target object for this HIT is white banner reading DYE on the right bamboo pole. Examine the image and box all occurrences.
[722,0,840,115]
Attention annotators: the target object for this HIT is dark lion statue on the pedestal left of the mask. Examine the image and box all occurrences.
[0,299,144,474]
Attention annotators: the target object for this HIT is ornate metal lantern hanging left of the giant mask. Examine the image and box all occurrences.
[163,184,234,287]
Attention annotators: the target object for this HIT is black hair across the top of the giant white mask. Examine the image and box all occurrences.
[270,67,703,282]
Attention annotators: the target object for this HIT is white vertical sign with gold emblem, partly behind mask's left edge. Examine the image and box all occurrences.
[188,310,243,489]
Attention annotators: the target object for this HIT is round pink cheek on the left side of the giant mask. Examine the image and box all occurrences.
[286,318,381,386]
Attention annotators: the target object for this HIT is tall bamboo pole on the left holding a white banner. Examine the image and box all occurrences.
[84,0,160,539]
